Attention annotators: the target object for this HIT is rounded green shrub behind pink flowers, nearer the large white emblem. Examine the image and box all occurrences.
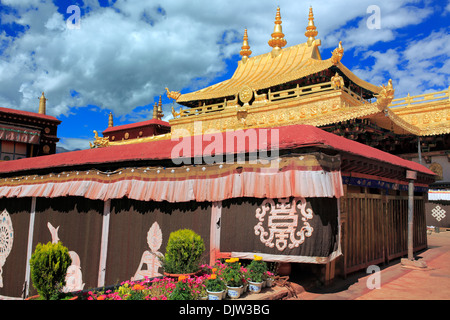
[161,229,205,274]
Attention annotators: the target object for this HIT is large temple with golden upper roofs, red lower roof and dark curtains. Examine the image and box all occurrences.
[0,8,444,297]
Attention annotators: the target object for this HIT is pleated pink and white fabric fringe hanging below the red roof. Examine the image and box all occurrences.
[0,154,343,202]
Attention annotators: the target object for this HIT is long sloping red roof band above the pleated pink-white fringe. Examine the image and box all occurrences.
[0,125,435,176]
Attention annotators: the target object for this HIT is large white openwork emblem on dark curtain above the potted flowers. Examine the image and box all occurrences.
[254,197,314,251]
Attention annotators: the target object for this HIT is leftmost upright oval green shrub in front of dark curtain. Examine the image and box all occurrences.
[30,242,72,300]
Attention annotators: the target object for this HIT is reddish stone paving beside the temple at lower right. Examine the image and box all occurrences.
[274,231,450,300]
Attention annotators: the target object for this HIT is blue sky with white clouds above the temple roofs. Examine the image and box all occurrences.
[0,0,450,149]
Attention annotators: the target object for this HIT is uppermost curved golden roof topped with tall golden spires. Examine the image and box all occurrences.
[176,8,380,104]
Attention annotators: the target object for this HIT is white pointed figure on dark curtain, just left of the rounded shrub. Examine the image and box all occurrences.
[131,222,162,281]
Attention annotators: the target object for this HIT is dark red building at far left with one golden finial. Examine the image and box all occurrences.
[0,93,61,161]
